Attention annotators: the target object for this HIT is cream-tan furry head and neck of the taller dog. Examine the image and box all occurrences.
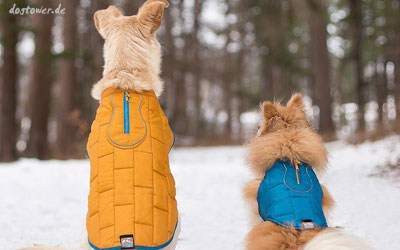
[92,0,168,100]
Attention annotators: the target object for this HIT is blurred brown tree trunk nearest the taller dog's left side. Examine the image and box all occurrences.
[57,0,79,158]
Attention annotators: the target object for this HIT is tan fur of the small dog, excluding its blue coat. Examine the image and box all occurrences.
[243,94,368,250]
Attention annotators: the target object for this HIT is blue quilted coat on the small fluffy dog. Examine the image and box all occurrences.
[257,161,328,229]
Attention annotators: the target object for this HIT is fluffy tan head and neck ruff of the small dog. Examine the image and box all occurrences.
[247,94,327,177]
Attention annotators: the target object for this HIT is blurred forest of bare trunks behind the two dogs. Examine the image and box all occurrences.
[0,0,400,161]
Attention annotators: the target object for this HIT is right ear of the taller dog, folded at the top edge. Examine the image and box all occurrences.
[138,0,169,35]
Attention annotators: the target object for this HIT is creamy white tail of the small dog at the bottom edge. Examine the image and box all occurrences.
[303,228,373,250]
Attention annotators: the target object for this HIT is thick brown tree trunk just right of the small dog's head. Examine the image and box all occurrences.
[309,0,335,136]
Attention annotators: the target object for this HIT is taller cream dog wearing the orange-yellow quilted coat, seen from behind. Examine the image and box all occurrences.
[19,0,180,250]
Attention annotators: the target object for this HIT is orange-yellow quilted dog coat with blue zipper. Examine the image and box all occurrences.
[86,89,178,250]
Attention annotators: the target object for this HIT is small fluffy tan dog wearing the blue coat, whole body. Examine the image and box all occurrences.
[244,94,370,250]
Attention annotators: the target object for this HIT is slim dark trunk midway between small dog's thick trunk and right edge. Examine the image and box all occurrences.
[349,0,366,133]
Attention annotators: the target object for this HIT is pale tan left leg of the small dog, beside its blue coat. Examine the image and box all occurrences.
[243,179,264,226]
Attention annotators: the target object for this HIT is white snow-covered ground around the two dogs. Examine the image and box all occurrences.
[0,137,400,250]
